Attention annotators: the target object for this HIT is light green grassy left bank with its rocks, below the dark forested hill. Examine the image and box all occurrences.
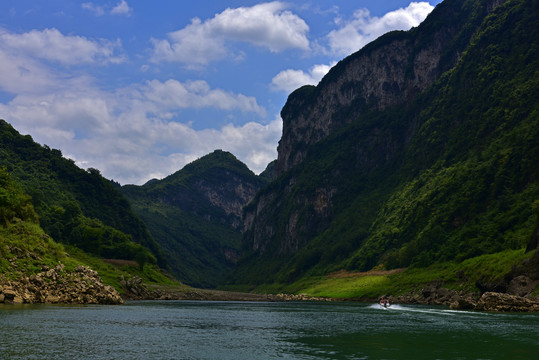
[0,168,177,303]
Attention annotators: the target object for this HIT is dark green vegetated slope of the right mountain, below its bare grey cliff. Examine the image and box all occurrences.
[234,0,539,292]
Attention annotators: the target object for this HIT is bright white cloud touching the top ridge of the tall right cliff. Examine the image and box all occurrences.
[327,2,434,56]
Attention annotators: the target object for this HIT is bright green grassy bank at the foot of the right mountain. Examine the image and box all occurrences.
[243,249,538,299]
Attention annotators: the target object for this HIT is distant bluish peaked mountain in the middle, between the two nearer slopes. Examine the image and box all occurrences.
[122,150,271,287]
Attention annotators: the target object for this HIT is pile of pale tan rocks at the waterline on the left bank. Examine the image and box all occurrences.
[0,264,123,304]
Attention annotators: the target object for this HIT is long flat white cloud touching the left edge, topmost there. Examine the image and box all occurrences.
[0,28,125,65]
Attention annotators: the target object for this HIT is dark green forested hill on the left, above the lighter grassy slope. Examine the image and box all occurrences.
[0,120,166,267]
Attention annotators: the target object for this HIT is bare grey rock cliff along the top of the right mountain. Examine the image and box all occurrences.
[276,0,504,175]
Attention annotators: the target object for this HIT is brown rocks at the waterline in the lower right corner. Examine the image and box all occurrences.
[475,292,539,312]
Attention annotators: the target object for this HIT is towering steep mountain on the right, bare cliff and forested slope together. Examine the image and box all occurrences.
[231,0,539,285]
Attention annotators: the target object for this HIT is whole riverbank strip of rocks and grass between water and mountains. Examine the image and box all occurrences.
[0,251,539,312]
